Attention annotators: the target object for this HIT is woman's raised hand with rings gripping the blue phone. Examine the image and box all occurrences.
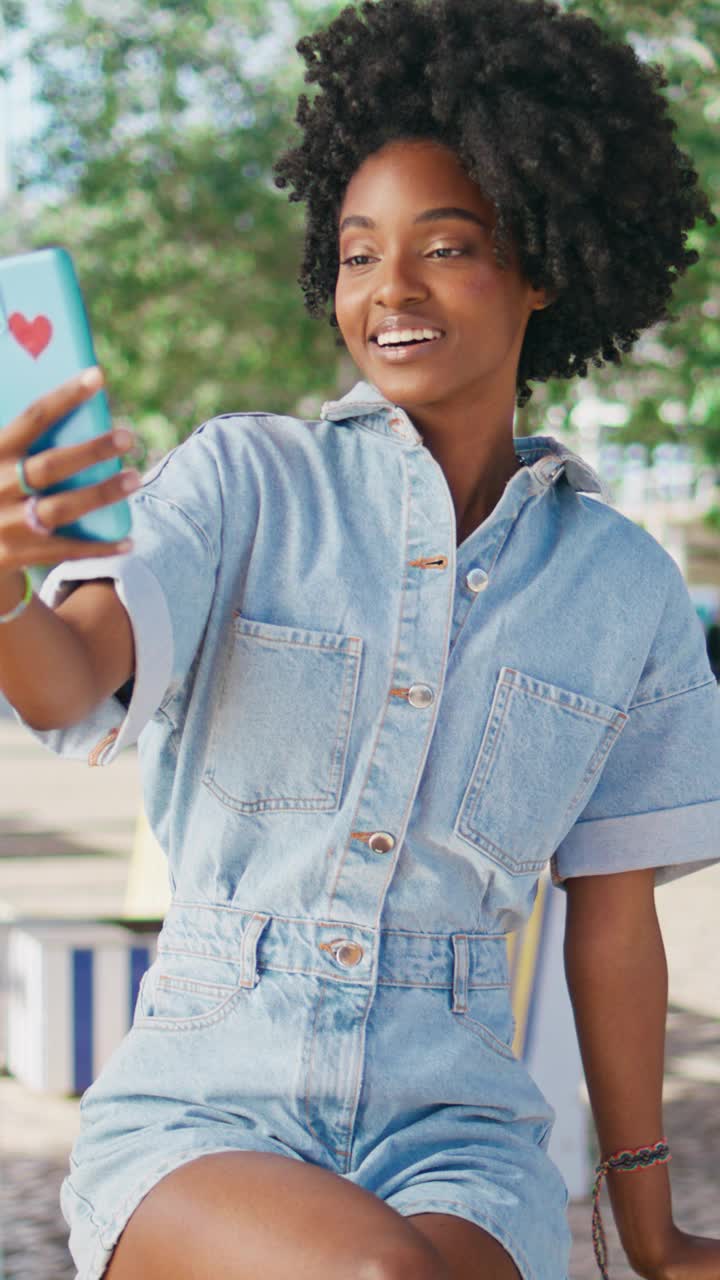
[0,369,141,581]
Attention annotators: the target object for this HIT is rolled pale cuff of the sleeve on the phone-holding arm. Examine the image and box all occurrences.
[15,556,173,765]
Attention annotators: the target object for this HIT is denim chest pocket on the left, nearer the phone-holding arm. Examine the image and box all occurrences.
[202,613,363,813]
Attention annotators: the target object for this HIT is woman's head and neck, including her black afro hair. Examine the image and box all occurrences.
[270,0,715,543]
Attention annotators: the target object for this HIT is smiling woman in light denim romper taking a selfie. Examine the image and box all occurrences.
[0,0,720,1280]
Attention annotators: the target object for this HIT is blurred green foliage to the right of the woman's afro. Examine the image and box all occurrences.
[520,0,720,462]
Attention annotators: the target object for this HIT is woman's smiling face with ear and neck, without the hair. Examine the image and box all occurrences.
[334,140,548,541]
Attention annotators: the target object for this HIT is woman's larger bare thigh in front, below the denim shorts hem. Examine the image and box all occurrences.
[106,1152,445,1280]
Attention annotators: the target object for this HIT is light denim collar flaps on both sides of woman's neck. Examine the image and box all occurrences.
[320,381,610,502]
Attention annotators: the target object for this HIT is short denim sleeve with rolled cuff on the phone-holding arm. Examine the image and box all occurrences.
[18,429,222,764]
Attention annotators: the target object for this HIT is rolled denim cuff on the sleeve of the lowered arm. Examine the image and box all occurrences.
[551,800,720,887]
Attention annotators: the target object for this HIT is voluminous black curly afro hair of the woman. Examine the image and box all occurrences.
[274,0,716,406]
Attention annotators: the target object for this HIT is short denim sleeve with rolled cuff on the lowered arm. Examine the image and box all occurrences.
[552,557,720,884]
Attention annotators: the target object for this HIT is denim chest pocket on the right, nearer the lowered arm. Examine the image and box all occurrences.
[455,667,628,874]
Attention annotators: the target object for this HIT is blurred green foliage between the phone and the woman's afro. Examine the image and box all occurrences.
[0,0,348,452]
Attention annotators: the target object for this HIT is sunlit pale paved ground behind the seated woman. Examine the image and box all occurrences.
[0,716,720,1280]
